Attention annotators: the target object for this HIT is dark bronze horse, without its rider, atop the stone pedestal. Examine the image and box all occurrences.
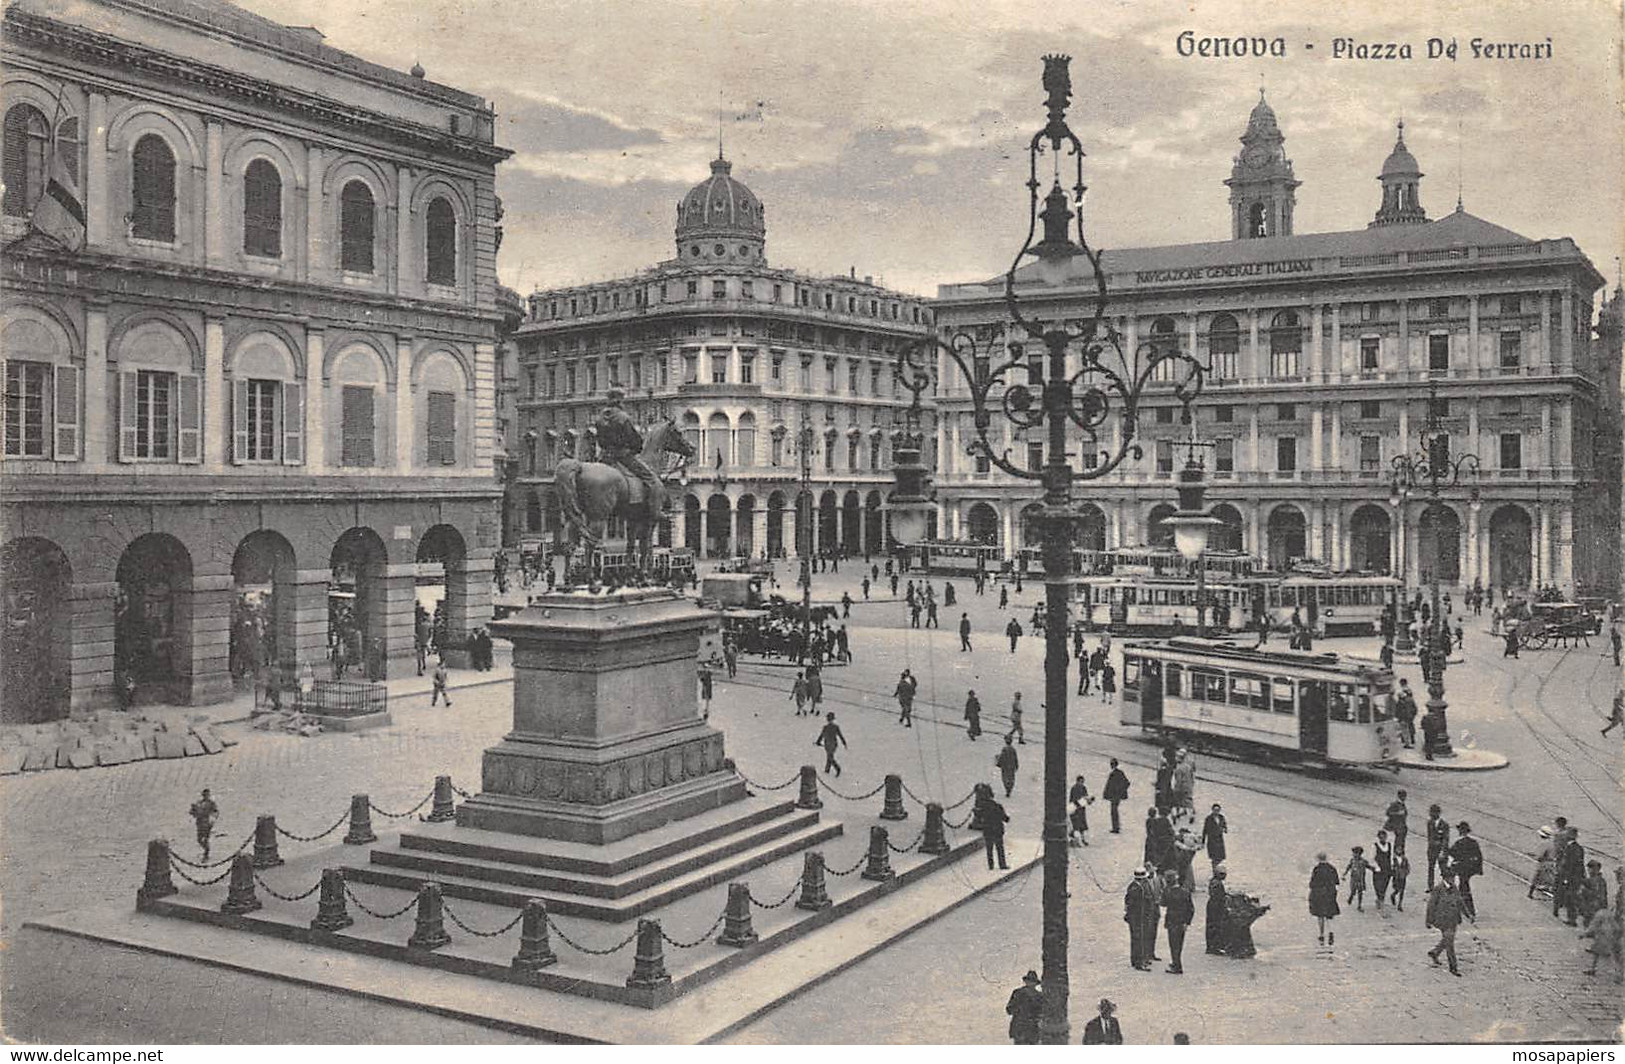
[553,419,694,569]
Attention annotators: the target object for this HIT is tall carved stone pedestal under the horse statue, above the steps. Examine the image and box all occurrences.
[457,588,746,845]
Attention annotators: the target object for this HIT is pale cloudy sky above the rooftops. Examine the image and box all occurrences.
[239,0,1625,296]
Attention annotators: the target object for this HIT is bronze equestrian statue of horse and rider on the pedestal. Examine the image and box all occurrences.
[553,388,694,573]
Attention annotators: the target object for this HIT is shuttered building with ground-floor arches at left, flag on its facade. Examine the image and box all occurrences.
[0,0,509,721]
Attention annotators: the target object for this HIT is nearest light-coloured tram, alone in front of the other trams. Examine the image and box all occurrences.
[1118,638,1399,770]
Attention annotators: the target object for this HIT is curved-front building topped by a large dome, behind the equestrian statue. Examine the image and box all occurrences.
[507,154,931,557]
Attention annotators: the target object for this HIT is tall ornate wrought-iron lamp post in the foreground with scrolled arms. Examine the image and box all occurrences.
[891,55,1203,1045]
